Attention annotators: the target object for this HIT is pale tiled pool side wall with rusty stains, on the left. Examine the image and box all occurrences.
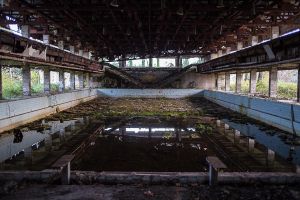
[0,89,97,132]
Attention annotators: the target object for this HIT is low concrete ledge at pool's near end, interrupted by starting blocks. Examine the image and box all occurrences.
[0,170,300,184]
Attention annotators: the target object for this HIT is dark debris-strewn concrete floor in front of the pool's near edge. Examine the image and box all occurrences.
[0,184,300,200]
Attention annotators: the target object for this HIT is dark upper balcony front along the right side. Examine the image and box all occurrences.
[197,31,300,73]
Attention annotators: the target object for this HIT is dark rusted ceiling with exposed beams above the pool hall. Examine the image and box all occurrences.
[0,0,300,60]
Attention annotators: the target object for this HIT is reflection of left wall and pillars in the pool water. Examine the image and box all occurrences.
[0,118,87,169]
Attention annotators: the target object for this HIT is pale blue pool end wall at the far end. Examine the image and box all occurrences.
[98,89,203,98]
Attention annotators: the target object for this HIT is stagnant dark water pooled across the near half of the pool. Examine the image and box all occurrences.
[0,99,300,172]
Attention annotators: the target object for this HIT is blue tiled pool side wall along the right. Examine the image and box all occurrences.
[203,90,300,136]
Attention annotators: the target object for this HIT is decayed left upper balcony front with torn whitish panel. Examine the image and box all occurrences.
[0,29,102,72]
